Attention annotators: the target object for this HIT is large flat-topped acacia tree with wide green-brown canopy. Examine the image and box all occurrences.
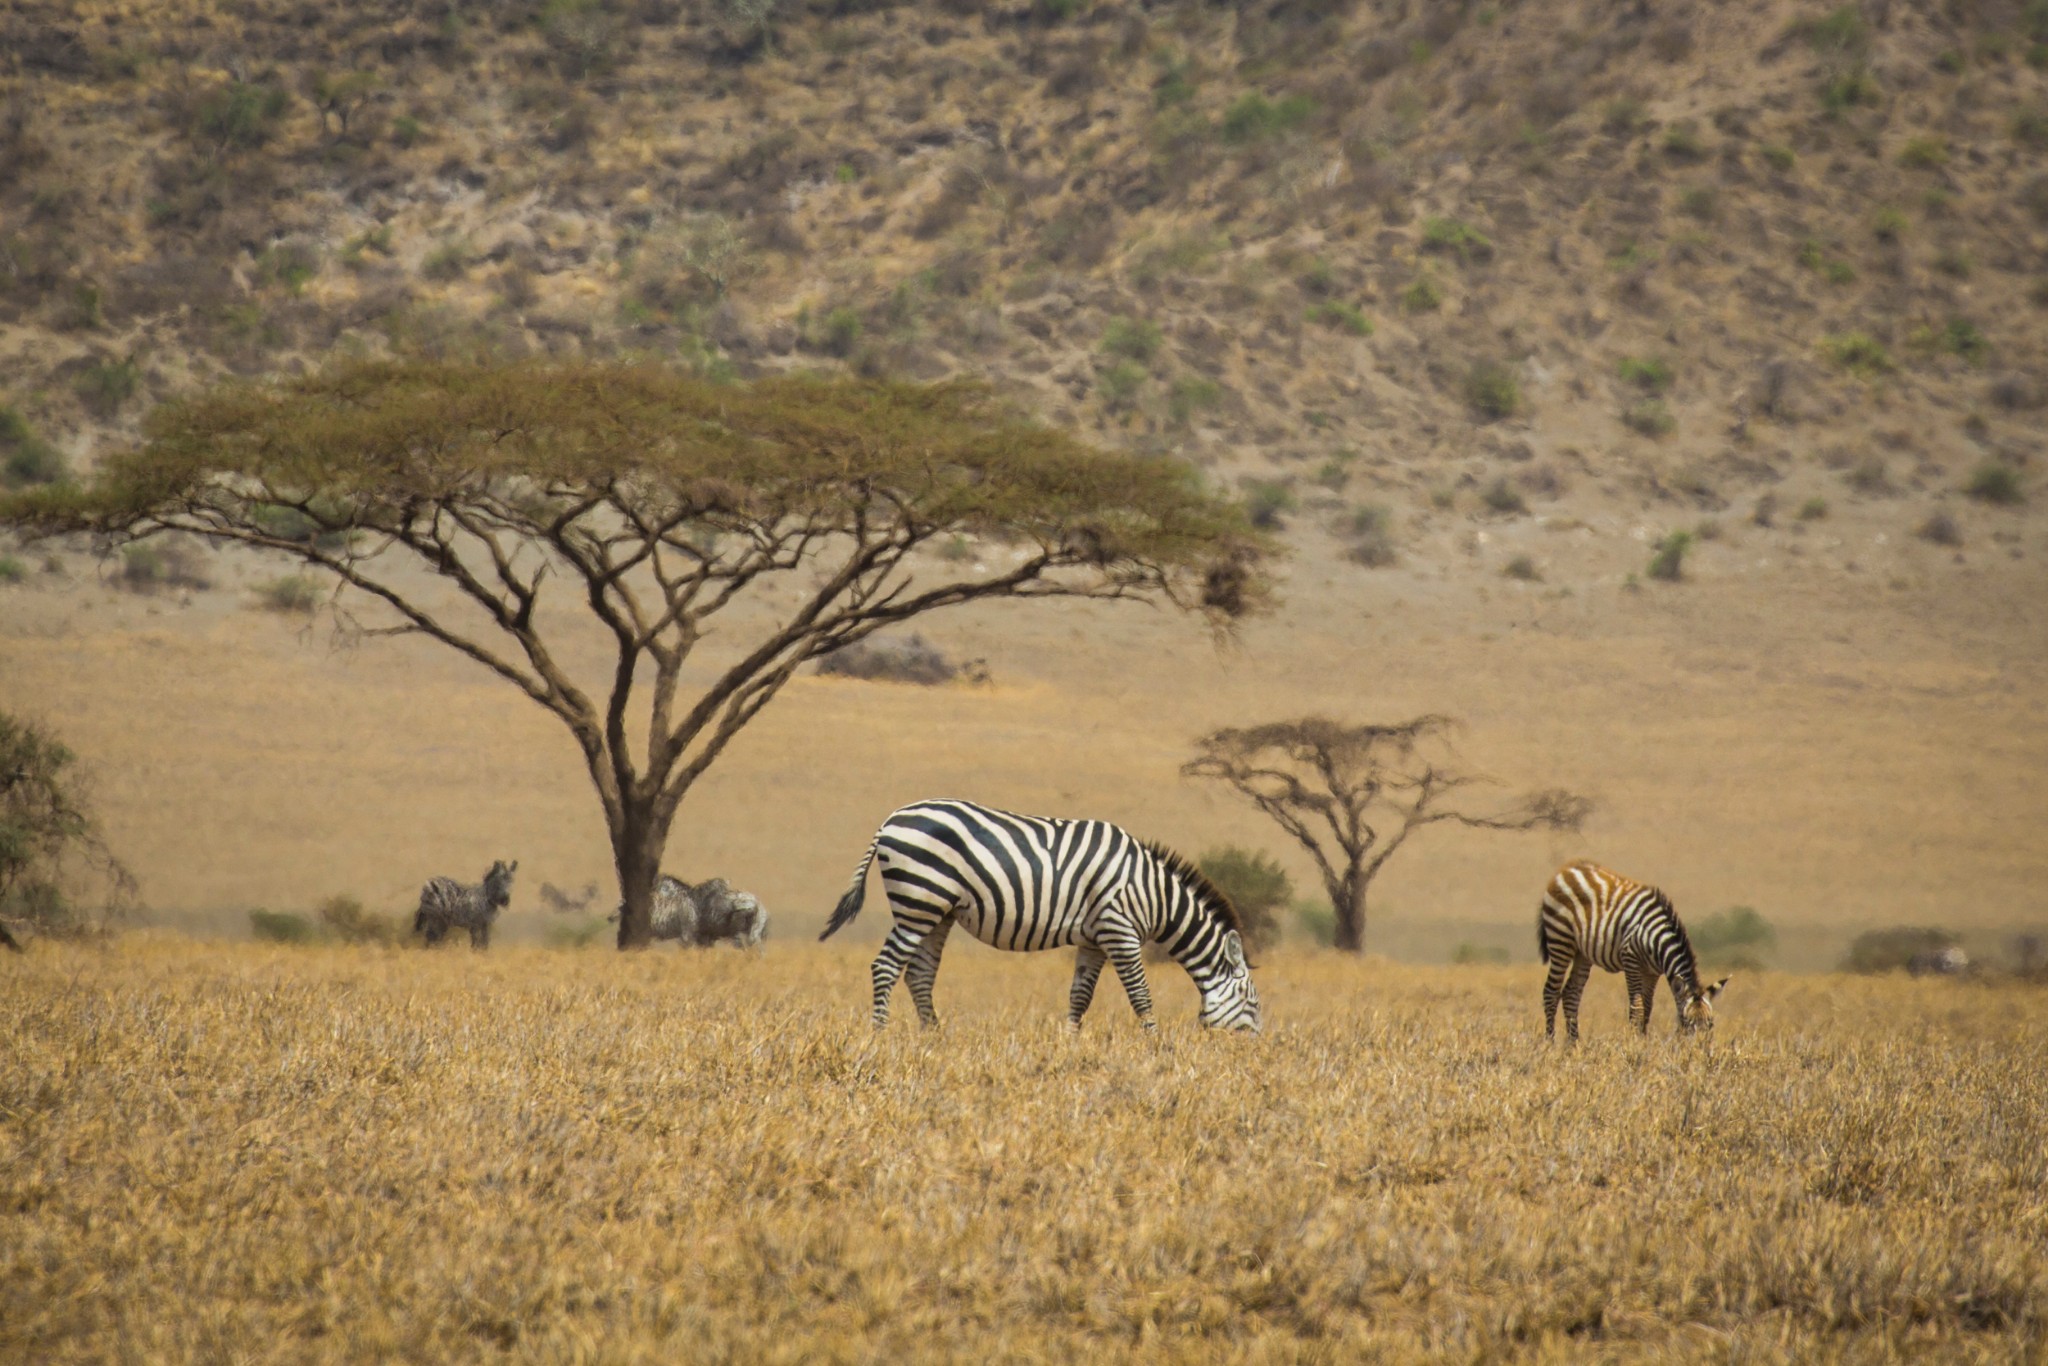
[0,362,1260,948]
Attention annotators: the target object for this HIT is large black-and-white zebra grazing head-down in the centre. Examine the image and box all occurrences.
[819,801,1260,1032]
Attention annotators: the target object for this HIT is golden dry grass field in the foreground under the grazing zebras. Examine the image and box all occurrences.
[0,938,2048,1362]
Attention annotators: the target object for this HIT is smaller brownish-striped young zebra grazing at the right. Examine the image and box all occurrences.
[1536,862,1729,1042]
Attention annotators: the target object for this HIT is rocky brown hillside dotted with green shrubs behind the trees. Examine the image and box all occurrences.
[0,0,2048,573]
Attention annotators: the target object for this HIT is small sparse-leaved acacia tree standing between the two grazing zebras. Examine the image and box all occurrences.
[1182,715,1591,952]
